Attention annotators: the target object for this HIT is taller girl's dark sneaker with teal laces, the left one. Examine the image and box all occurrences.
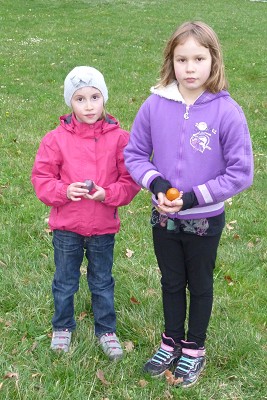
[144,333,182,377]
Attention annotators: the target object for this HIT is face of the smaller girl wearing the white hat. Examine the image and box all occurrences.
[71,86,104,124]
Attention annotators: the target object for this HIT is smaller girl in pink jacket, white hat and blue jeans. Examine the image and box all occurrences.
[31,66,140,360]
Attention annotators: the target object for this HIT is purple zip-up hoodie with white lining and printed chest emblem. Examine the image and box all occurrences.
[124,81,253,219]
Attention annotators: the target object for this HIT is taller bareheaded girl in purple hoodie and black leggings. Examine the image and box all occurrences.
[124,22,253,387]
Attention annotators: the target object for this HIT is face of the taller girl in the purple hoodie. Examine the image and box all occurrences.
[173,36,212,99]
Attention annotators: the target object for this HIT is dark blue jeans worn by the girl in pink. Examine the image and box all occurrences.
[52,230,116,336]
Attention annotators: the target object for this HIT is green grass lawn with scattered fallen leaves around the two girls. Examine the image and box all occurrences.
[0,0,267,400]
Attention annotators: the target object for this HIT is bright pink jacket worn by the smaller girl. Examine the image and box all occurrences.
[31,114,140,236]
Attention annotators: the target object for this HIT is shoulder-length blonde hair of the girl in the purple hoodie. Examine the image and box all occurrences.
[157,21,228,93]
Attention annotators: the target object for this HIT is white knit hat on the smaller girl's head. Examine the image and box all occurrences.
[64,66,108,107]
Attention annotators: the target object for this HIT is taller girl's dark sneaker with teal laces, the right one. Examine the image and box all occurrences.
[174,341,206,387]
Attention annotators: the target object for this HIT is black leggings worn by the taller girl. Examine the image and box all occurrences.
[153,228,221,347]
